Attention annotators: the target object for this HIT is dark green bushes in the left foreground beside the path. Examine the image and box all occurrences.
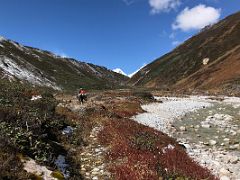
[0,80,82,179]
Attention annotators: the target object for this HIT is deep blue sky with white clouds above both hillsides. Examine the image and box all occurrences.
[0,0,240,74]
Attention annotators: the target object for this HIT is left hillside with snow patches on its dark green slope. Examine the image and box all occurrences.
[0,37,128,90]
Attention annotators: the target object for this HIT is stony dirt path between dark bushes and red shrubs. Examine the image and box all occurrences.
[56,96,111,180]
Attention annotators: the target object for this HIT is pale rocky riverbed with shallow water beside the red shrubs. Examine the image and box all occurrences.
[133,96,240,180]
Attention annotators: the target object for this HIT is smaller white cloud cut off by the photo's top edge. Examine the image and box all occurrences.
[149,0,181,14]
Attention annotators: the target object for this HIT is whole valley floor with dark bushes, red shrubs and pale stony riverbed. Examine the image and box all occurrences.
[0,84,235,180]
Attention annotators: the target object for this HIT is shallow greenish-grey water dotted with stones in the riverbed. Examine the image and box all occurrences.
[173,102,240,150]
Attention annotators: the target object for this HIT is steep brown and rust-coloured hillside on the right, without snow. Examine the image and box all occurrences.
[130,12,240,92]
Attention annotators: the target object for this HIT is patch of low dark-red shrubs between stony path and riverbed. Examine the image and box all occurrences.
[98,119,218,180]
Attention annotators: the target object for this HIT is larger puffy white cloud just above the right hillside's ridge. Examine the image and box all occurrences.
[172,4,221,31]
